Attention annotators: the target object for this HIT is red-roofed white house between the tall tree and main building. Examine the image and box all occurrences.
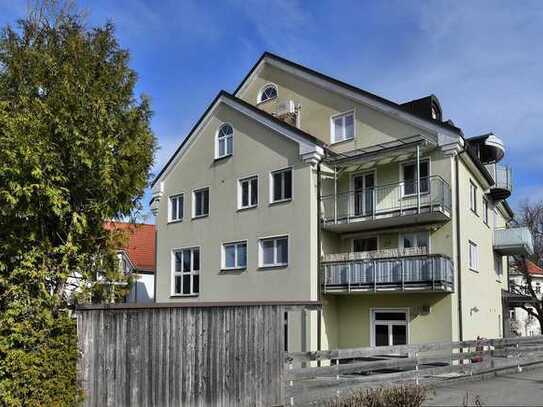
[109,222,156,303]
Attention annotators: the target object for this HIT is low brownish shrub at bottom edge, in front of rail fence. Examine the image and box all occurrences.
[328,385,426,407]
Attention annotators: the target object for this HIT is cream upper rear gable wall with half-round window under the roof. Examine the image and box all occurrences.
[238,65,434,151]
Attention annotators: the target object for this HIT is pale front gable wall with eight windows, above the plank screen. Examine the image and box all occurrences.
[156,105,317,302]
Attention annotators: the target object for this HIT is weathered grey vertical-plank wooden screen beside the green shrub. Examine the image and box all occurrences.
[77,304,292,407]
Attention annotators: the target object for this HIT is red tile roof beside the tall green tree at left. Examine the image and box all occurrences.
[106,222,156,273]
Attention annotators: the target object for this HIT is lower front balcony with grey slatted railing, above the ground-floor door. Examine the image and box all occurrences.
[321,248,454,294]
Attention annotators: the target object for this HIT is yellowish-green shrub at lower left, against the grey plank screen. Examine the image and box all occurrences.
[0,297,81,407]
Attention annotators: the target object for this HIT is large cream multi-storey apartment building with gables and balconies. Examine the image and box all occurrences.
[151,53,531,350]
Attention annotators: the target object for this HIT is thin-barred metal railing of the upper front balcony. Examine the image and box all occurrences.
[321,176,451,223]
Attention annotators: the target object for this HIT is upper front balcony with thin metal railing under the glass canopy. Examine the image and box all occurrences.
[321,176,451,233]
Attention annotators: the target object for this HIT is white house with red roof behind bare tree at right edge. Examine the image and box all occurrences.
[509,260,543,336]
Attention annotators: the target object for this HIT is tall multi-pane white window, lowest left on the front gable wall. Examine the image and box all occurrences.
[172,247,200,295]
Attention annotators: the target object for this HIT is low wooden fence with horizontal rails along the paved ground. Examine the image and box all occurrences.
[285,336,543,405]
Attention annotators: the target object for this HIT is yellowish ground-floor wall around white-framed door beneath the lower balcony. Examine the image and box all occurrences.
[325,293,452,349]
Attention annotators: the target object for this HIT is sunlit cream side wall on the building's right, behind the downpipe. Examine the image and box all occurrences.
[459,160,506,340]
